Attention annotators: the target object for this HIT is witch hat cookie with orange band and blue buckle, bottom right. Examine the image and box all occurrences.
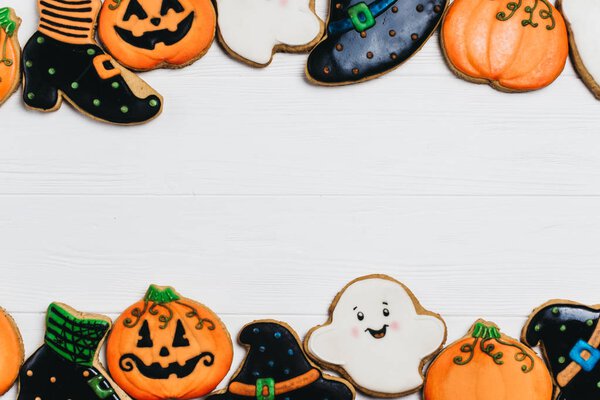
[523,300,600,400]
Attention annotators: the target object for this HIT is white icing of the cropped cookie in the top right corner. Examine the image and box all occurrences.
[561,0,600,87]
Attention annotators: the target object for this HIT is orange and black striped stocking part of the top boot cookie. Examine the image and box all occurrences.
[38,0,101,44]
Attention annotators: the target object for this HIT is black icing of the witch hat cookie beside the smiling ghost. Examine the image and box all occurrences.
[206,322,354,400]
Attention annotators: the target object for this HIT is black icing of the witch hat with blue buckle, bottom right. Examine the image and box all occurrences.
[524,304,600,400]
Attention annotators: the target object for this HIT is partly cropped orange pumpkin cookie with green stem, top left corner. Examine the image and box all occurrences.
[0,7,21,105]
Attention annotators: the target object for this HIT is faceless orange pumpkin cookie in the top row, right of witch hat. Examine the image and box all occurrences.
[441,0,569,92]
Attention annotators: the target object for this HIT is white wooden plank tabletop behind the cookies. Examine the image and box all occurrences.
[0,0,600,399]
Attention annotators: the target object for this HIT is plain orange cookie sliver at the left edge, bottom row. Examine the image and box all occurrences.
[0,308,24,395]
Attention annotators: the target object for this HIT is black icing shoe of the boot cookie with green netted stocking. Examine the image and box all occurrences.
[17,345,120,400]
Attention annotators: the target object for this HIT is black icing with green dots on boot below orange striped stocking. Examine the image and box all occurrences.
[22,32,161,124]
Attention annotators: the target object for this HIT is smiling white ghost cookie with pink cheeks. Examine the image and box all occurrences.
[304,275,446,397]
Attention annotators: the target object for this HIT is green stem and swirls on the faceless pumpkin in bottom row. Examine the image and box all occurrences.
[453,322,534,373]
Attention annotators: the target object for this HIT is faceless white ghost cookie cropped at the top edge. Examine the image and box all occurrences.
[216,0,324,67]
